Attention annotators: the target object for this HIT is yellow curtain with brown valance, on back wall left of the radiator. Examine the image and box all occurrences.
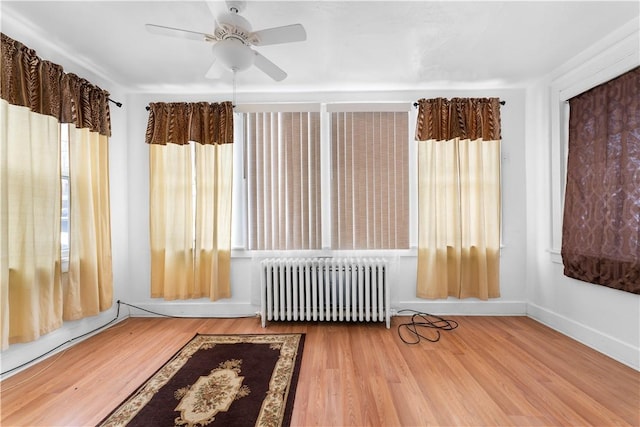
[146,102,233,300]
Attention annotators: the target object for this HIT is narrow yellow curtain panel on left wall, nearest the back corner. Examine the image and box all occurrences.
[63,126,113,320]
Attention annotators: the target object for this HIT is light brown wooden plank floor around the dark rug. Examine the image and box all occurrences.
[0,317,640,427]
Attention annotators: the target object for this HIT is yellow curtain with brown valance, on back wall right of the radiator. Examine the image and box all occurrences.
[416,98,501,299]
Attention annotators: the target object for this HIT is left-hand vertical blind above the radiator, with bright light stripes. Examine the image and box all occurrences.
[245,112,322,250]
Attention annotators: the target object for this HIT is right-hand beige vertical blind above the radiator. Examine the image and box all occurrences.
[331,112,409,249]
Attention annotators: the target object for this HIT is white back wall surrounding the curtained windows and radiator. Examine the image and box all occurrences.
[125,89,526,316]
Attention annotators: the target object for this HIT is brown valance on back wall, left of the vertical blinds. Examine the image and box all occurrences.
[146,101,233,145]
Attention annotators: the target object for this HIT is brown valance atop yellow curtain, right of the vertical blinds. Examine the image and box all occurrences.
[416,98,501,141]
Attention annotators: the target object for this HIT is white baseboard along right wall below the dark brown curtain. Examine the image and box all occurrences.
[527,303,640,371]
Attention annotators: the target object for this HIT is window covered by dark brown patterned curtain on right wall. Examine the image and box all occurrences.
[562,67,640,294]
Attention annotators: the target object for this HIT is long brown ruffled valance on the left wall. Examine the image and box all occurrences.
[0,33,111,136]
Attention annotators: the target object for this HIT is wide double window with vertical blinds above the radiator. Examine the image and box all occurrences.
[242,104,410,250]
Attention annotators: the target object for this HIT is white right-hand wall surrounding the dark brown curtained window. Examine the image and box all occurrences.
[526,19,640,369]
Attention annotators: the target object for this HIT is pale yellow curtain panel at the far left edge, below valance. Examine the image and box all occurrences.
[0,99,62,349]
